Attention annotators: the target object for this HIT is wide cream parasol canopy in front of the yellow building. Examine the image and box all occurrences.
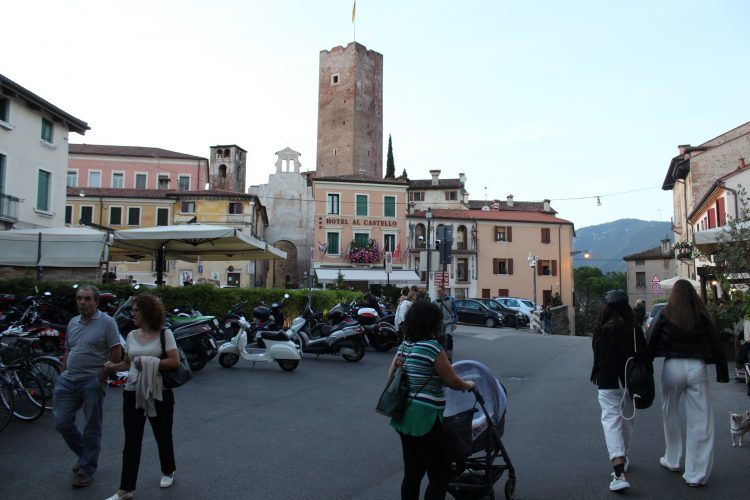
[111,224,286,262]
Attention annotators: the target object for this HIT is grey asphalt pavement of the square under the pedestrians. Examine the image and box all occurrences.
[0,325,750,500]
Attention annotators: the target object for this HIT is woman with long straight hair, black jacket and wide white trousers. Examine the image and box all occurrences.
[648,280,729,486]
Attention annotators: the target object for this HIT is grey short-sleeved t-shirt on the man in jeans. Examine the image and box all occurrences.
[63,311,120,382]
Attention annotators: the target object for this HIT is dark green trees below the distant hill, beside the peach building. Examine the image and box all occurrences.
[573,266,627,335]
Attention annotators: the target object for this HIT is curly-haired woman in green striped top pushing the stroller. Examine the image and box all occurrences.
[388,301,475,500]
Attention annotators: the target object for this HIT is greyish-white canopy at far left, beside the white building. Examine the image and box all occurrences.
[0,227,108,267]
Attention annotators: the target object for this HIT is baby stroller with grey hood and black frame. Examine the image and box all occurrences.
[445,361,516,500]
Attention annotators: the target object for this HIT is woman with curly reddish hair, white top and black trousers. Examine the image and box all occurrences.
[104,294,180,500]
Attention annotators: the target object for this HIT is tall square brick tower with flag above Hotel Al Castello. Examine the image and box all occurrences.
[315,42,383,177]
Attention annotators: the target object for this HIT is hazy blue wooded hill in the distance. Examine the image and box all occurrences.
[573,219,673,273]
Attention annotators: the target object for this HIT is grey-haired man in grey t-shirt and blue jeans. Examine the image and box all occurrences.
[53,285,122,488]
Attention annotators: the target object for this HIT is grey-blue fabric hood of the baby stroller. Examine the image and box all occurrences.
[445,361,508,436]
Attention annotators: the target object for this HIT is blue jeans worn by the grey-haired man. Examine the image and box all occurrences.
[54,375,104,477]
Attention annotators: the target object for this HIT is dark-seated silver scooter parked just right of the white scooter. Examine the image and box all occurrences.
[293,303,365,362]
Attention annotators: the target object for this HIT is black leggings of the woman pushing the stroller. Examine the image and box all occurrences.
[398,418,450,500]
